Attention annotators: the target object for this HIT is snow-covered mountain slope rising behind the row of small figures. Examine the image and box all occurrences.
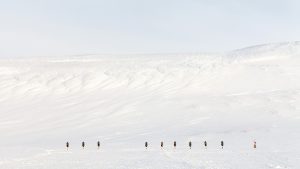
[0,42,300,150]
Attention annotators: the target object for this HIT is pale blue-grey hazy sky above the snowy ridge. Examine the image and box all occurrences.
[0,0,300,57]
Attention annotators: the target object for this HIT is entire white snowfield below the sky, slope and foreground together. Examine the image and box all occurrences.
[0,42,300,169]
